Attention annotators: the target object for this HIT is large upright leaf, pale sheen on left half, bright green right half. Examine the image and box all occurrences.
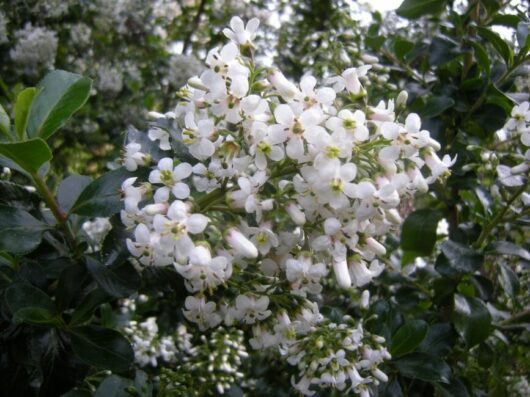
[27,70,92,139]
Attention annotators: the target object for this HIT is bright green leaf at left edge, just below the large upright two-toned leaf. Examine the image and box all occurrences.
[0,138,53,174]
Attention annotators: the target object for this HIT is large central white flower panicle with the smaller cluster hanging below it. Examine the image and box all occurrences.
[122,17,455,395]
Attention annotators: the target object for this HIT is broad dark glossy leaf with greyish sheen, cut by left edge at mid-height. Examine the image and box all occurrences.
[0,205,48,254]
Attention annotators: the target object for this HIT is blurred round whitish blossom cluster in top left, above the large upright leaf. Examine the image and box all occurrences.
[9,22,58,71]
